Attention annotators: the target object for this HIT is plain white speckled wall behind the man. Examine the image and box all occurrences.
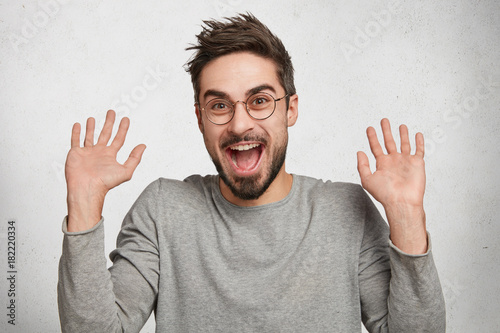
[0,0,500,332]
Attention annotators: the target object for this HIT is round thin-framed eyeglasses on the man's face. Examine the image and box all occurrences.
[197,92,288,125]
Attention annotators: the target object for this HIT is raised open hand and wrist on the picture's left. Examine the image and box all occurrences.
[65,110,146,232]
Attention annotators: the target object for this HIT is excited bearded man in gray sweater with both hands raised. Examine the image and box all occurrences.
[58,15,445,332]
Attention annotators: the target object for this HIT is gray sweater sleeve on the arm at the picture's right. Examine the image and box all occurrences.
[358,191,446,332]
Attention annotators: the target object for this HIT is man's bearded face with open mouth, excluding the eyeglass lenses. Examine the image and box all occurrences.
[196,52,297,200]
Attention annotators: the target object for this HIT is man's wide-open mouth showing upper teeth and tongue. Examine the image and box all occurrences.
[226,143,264,174]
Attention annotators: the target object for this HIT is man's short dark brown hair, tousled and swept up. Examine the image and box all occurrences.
[186,13,295,105]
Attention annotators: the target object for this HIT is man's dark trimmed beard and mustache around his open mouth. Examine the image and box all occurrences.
[208,133,288,200]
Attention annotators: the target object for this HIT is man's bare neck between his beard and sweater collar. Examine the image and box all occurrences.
[219,164,293,207]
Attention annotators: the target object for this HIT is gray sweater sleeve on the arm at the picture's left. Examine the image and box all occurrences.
[58,183,159,332]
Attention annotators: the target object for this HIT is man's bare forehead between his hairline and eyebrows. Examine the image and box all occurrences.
[200,52,284,100]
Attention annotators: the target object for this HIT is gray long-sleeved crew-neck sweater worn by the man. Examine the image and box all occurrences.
[58,176,445,333]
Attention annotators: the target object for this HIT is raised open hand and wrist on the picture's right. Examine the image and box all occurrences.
[358,119,427,254]
